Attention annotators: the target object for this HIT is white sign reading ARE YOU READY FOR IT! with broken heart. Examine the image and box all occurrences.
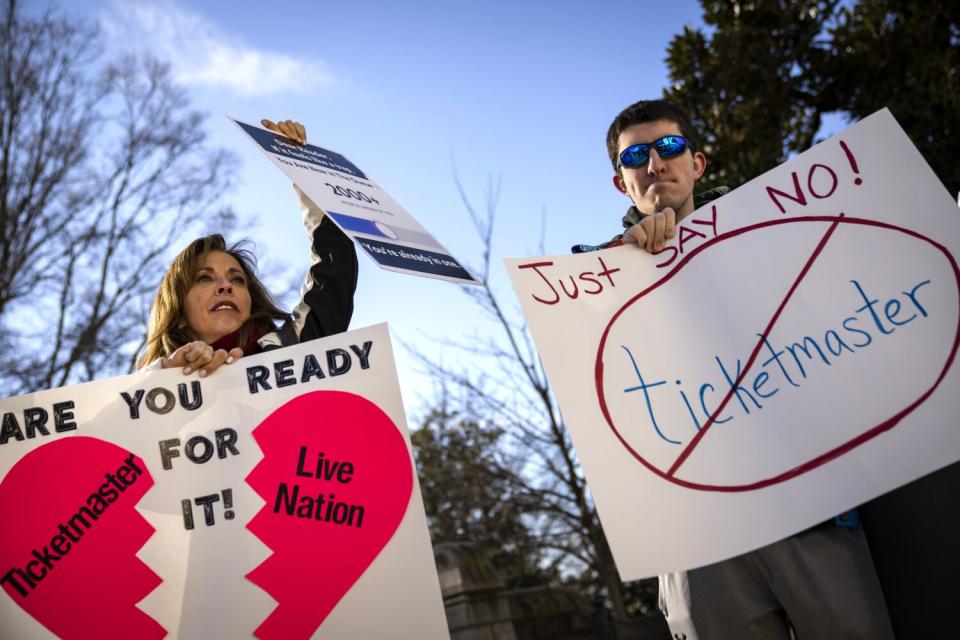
[0,325,448,639]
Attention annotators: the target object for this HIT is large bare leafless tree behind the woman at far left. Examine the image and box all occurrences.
[0,0,236,395]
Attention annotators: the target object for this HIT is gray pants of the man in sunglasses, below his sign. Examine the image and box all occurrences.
[660,525,893,640]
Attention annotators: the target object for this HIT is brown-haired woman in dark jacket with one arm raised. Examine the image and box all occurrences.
[140,120,357,377]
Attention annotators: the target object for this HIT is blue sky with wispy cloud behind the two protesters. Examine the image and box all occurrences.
[65,0,701,416]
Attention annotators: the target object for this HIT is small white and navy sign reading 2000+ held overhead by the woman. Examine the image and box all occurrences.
[231,118,479,284]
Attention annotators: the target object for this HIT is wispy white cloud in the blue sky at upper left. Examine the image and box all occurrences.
[100,0,334,97]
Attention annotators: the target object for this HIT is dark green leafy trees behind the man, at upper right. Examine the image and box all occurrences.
[664,0,960,193]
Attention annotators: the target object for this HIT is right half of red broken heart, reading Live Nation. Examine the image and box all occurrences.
[247,391,413,638]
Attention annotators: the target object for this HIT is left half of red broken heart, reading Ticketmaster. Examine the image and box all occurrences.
[0,436,166,639]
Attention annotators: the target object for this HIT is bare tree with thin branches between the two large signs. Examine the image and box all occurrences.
[405,168,640,618]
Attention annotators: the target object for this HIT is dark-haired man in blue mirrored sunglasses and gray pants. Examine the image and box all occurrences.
[596,100,893,640]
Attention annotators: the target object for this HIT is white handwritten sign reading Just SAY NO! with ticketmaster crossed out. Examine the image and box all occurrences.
[507,110,960,580]
